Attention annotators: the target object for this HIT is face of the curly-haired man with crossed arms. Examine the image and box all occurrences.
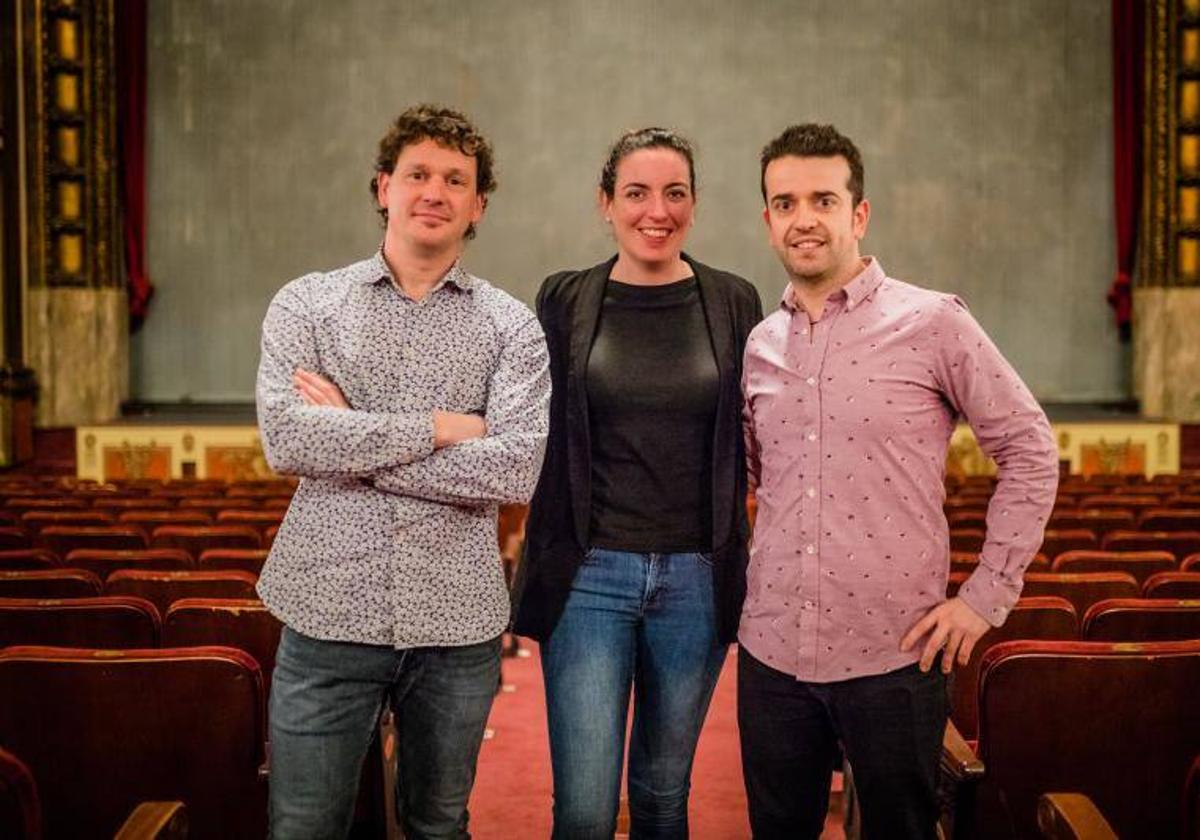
[376,139,484,252]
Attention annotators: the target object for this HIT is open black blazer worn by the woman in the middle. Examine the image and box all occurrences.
[512,254,762,642]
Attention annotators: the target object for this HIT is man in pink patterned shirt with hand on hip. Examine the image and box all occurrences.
[738,125,1058,840]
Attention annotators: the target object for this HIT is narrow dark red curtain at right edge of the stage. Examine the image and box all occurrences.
[1108,0,1146,341]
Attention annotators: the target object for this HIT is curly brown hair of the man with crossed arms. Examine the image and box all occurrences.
[371,104,496,239]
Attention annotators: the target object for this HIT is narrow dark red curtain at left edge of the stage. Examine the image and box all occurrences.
[113,0,154,330]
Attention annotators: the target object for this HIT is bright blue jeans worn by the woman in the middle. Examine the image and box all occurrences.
[541,548,726,840]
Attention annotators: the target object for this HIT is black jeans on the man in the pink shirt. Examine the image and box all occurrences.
[738,648,947,840]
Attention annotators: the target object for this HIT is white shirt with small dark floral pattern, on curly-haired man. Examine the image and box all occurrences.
[257,252,550,648]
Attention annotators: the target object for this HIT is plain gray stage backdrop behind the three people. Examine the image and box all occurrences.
[132,0,1129,401]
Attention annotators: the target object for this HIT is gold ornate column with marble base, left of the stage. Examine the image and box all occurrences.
[17,0,128,427]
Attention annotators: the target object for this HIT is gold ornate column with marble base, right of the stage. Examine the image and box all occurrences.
[1133,0,1200,422]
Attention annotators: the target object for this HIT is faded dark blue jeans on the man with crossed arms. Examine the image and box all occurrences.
[270,626,500,840]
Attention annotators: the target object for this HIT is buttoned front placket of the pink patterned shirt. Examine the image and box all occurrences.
[792,302,836,677]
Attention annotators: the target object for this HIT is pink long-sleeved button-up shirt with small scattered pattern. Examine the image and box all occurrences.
[738,258,1058,683]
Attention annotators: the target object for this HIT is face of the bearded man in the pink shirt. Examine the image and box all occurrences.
[763,155,870,286]
